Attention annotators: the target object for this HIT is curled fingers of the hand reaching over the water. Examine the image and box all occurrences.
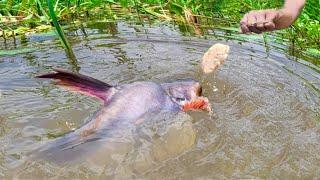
[240,10,277,33]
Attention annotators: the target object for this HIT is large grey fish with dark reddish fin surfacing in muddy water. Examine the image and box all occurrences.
[36,69,210,162]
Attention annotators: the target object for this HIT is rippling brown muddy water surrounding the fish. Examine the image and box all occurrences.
[0,21,320,179]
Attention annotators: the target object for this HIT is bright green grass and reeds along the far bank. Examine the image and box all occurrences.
[0,0,320,56]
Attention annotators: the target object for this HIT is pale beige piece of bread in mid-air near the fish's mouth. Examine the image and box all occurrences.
[201,43,229,73]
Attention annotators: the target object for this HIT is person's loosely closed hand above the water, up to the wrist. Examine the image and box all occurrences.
[240,9,295,33]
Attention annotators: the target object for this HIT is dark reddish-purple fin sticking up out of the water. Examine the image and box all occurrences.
[36,68,112,103]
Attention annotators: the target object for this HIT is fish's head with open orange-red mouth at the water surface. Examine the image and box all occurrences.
[162,79,210,111]
